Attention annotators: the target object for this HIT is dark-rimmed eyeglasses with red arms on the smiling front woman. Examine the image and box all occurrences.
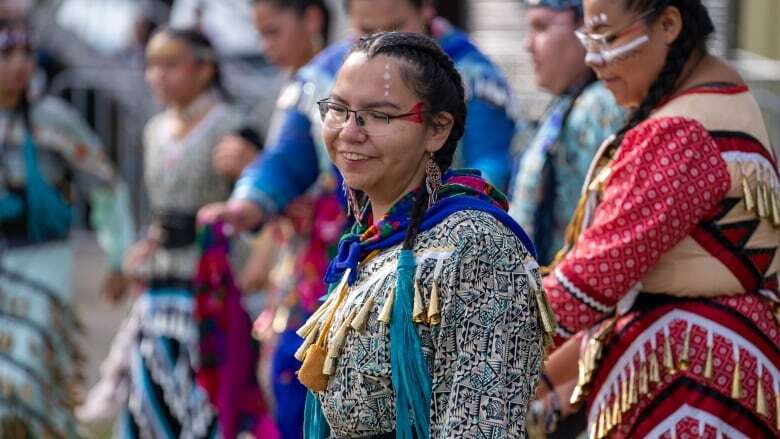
[317,99,431,136]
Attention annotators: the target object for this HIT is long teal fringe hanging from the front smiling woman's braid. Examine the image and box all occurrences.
[390,250,431,439]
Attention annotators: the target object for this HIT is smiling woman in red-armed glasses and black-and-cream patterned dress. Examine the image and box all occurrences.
[297,32,553,439]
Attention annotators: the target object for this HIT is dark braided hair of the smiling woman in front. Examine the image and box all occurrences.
[350,32,466,250]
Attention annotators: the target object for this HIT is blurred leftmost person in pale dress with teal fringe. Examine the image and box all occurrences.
[0,16,134,438]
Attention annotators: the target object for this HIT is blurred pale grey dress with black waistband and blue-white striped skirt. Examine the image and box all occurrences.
[117,92,242,438]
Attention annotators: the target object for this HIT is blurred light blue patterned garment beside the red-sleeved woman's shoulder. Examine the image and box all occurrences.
[509,82,625,265]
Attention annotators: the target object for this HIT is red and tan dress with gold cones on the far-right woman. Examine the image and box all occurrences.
[544,84,780,438]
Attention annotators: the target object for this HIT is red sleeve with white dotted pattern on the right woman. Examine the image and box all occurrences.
[544,117,731,341]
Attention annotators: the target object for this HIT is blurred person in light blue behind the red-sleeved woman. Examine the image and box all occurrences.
[509,0,623,264]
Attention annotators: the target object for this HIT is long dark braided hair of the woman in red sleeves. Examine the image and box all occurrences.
[610,0,715,150]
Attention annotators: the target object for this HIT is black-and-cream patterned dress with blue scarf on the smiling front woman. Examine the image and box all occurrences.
[299,174,543,438]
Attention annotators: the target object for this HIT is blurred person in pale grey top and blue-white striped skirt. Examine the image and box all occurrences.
[117,28,272,438]
